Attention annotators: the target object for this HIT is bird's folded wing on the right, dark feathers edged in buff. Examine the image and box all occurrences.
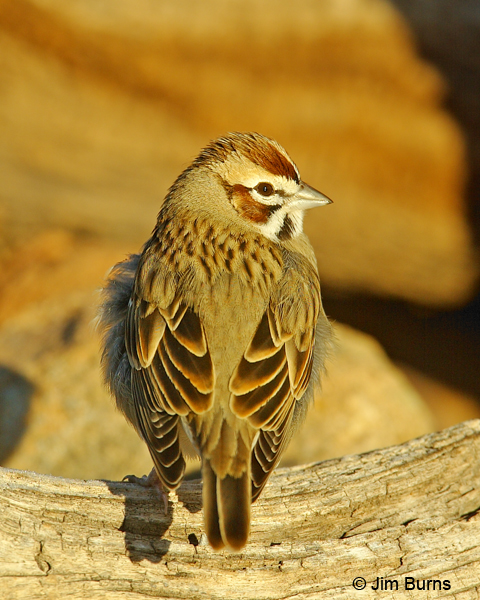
[230,266,320,501]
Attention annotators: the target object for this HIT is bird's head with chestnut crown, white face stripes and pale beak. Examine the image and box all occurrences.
[164,133,331,242]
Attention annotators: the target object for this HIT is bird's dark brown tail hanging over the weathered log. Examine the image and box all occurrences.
[202,459,252,550]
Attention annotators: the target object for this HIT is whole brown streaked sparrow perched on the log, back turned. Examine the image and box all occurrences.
[100,134,331,550]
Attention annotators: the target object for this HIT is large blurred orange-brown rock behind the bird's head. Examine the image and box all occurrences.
[0,0,478,306]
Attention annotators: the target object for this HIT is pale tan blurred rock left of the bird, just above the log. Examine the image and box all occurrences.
[0,292,151,479]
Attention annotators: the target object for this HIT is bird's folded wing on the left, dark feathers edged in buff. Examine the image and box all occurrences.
[125,295,215,489]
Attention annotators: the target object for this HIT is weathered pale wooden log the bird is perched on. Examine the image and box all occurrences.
[0,420,480,600]
